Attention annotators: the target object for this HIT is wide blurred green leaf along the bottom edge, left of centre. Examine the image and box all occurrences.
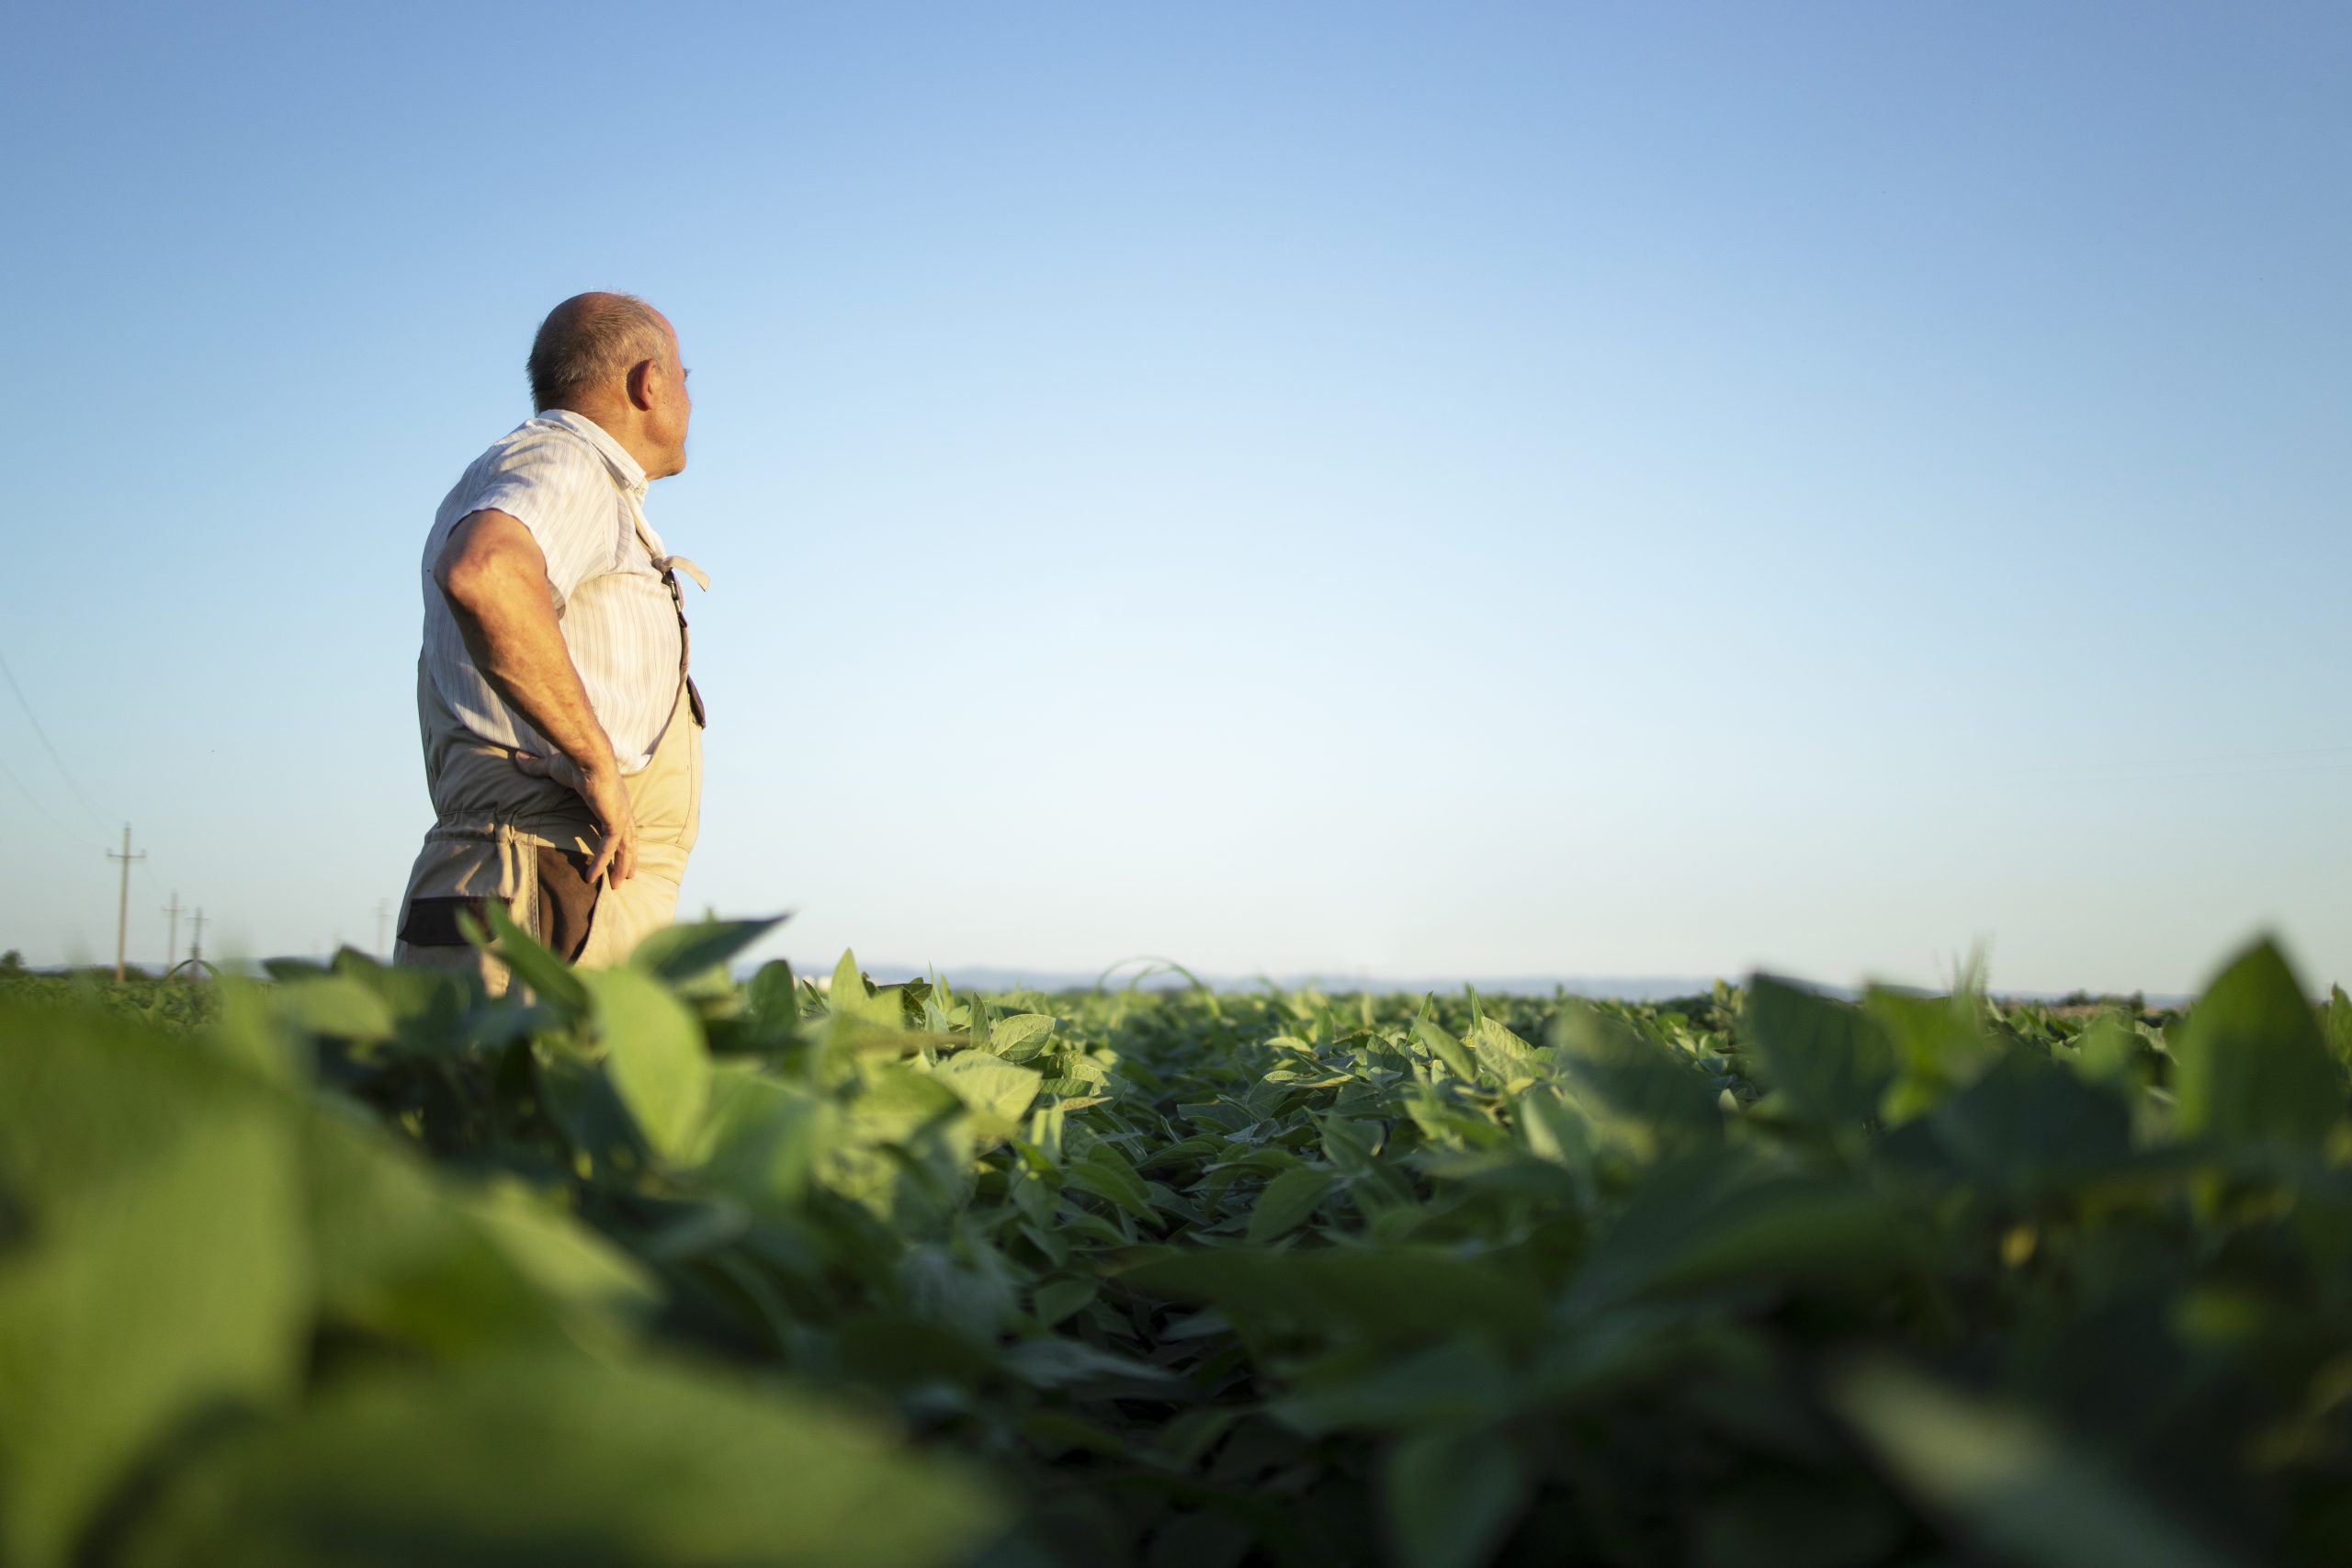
[125,1354,1004,1568]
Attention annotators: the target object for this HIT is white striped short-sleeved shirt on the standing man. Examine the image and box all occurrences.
[424,409,680,773]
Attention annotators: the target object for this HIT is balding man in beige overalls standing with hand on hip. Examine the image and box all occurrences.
[395,294,703,992]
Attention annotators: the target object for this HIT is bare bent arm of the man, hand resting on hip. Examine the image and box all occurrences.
[433,510,638,886]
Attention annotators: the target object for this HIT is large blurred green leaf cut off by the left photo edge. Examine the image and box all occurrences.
[0,1009,311,1568]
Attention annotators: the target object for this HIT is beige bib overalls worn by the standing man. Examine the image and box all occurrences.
[393,484,703,997]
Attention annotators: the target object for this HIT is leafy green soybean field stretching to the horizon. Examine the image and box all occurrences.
[0,921,2352,1568]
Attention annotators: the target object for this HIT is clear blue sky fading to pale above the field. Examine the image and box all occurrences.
[0,3,2352,989]
